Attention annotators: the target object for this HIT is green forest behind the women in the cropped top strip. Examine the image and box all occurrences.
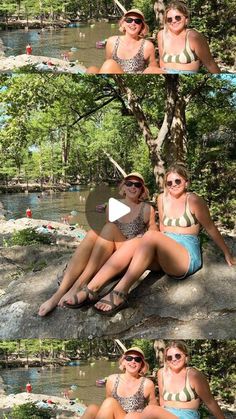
[0,0,236,67]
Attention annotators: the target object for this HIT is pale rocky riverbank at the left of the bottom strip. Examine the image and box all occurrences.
[0,392,86,419]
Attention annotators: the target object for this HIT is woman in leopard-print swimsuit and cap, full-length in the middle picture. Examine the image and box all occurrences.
[39,172,157,316]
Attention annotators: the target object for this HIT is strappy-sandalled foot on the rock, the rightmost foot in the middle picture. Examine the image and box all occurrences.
[94,289,128,316]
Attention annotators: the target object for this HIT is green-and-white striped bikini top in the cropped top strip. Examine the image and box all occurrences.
[162,29,199,64]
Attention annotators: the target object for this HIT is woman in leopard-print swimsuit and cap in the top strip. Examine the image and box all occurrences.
[87,9,161,74]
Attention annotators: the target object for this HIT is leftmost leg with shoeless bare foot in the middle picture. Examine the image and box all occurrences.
[38,230,98,316]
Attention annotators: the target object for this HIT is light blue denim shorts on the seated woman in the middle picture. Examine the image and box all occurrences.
[164,231,202,279]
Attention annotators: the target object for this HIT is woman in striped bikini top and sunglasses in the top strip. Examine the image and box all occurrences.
[158,0,220,73]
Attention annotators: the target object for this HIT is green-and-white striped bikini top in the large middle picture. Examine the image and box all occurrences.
[162,193,199,227]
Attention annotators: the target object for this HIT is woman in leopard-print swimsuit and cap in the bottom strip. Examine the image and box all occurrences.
[81,347,157,419]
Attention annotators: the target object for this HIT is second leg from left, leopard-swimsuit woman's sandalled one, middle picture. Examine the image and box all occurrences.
[59,223,125,305]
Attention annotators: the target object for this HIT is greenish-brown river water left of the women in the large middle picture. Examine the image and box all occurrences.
[0,186,117,230]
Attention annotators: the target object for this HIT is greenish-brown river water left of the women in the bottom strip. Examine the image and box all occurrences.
[0,360,119,405]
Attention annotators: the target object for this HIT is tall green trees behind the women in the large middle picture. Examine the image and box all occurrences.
[0,74,236,229]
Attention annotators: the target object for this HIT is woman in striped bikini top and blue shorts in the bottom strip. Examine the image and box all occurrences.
[134,341,224,419]
